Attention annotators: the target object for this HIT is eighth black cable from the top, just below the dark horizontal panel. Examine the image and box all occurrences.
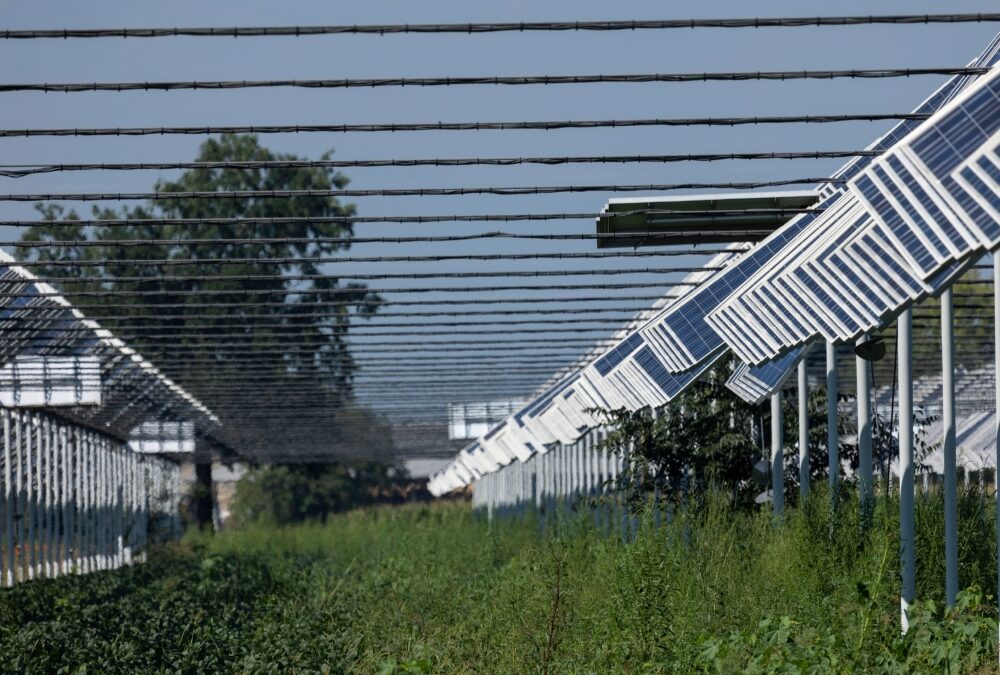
[0,249,731,272]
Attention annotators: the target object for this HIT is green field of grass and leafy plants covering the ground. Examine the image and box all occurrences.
[0,493,997,673]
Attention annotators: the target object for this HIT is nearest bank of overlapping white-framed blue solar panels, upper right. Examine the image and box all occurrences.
[708,69,1000,363]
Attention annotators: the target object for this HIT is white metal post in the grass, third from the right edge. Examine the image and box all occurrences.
[896,309,917,633]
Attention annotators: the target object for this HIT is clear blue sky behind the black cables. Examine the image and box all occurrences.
[0,0,998,470]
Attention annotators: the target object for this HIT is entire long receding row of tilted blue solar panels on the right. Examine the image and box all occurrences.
[430,30,1000,493]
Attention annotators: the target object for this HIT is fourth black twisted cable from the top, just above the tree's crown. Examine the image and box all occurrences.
[0,150,882,178]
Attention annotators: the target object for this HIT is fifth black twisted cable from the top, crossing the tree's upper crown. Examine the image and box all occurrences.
[0,177,844,202]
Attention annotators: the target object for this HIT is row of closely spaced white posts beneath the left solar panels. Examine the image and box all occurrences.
[0,408,180,587]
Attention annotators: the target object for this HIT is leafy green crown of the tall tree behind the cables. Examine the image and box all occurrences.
[18,135,380,404]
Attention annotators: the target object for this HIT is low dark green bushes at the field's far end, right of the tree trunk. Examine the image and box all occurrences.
[232,462,409,526]
